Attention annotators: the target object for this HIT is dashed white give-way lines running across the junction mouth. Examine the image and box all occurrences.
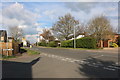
[41,53,120,71]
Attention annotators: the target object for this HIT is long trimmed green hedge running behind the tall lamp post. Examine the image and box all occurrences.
[61,37,97,49]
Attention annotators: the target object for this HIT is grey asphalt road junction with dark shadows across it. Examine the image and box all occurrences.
[3,47,120,78]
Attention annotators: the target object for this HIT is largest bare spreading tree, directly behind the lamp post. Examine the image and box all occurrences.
[52,13,83,40]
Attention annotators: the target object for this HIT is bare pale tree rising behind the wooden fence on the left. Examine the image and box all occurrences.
[9,26,23,41]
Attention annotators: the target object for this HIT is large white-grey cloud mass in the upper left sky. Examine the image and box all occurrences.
[0,3,40,34]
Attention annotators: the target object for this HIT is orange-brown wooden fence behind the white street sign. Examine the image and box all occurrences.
[0,42,19,56]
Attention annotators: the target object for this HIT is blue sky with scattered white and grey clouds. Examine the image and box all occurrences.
[0,0,118,43]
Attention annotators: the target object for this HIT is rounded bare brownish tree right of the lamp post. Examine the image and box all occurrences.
[86,16,114,41]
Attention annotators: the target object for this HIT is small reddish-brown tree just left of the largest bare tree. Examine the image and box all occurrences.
[42,29,55,41]
